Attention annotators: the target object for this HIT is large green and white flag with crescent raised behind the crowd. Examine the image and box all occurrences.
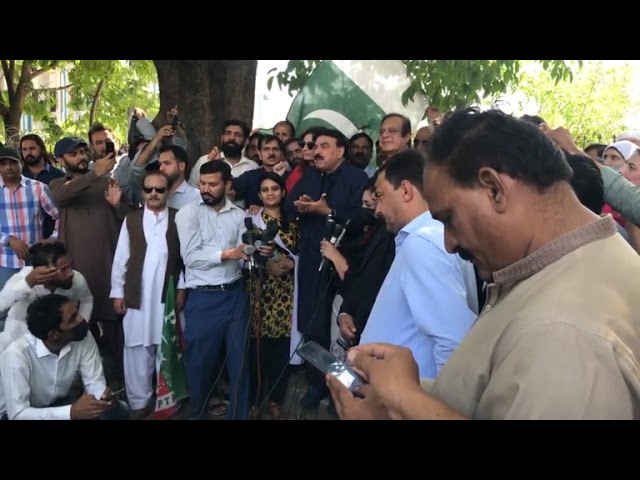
[287,60,427,142]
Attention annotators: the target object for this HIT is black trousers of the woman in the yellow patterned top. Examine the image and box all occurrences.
[249,337,291,406]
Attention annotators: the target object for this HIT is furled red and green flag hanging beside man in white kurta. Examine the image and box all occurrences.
[152,275,189,420]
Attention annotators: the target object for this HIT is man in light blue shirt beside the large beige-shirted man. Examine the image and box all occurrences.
[360,150,477,378]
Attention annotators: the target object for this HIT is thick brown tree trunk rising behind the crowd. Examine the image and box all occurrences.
[153,60,258,169]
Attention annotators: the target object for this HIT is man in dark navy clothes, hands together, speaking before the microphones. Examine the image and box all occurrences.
[285,129,367,408]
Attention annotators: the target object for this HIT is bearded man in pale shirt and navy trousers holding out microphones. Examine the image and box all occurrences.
[176,160,254,420]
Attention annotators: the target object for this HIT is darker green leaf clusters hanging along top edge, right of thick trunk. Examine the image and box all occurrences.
[267,60,581,115]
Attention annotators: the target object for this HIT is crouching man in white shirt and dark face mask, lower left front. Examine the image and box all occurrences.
[0,294,129,420]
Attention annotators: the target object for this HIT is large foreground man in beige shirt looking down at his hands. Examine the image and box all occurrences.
[328,109,640,419]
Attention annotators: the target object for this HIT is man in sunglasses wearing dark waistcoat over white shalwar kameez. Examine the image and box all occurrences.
[110,171,183,420]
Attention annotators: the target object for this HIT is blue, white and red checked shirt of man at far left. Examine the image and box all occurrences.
[0,175,60,268]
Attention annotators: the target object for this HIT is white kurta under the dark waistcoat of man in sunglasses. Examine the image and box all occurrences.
[110,207,169,347]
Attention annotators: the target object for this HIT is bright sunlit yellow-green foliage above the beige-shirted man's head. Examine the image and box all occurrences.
[517,61,639,148]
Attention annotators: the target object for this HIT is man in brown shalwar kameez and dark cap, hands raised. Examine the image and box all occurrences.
[49,137,131,380]
